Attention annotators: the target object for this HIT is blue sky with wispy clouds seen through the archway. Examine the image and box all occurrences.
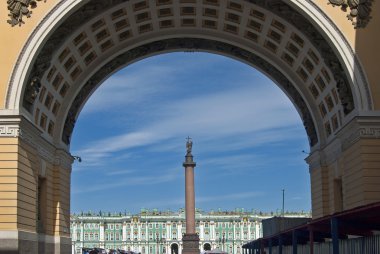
[71,53,311,213]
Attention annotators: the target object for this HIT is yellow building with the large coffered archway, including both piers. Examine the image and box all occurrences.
[0,0,380,253]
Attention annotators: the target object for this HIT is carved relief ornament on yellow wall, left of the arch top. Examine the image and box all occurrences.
[7,0,46,26]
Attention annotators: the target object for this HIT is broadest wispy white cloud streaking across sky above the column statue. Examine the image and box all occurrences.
[72,83,300,168]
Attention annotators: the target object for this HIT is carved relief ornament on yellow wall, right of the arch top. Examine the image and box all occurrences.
[329,0,373,28]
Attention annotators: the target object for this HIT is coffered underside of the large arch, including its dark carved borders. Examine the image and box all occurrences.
[8,0,371,149]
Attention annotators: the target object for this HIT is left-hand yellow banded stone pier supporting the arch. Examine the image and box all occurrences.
[0,115,71,253]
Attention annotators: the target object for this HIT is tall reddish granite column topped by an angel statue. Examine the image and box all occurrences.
[182,137,199,254]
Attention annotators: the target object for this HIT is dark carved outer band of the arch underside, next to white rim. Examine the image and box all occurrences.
[12,0,355,115]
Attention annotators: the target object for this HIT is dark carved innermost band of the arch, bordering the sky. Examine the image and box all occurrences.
[61,38,318,146]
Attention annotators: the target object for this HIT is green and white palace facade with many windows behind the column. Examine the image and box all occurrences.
[70,209,310,254]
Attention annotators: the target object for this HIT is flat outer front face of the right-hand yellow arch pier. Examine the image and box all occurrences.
[340,117,380,209]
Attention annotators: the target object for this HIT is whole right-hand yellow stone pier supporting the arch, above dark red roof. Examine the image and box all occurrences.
[306,116,380,218]
